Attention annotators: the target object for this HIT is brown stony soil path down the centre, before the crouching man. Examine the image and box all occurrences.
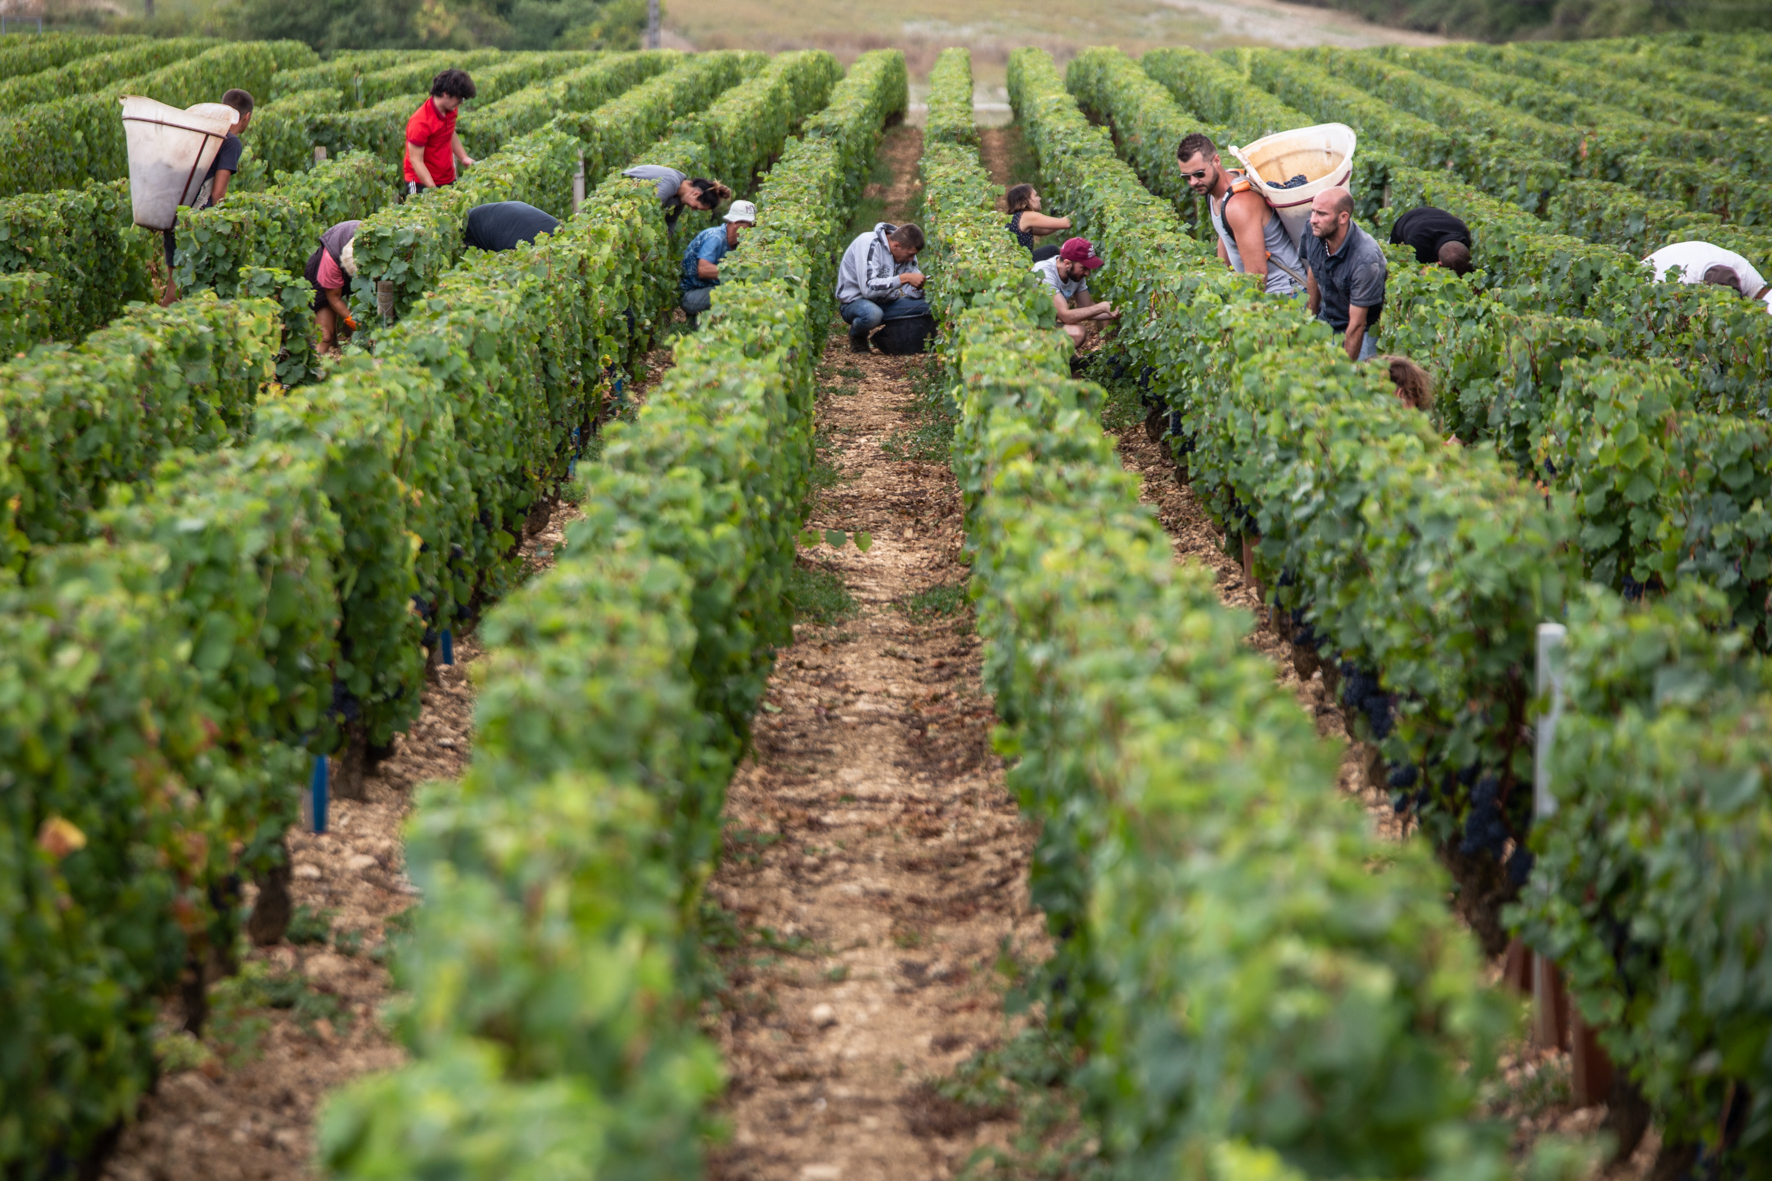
[711,333,1044,1181]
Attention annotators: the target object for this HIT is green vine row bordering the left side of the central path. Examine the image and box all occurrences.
[321,51,904,1179]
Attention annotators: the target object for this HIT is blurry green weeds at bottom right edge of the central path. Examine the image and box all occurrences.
[942,1027,1108,1181]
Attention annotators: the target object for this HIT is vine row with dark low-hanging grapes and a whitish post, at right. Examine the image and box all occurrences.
[1010,50,1772,1158]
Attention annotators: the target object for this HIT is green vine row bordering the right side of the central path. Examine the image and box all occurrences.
[925,51,1506,1177]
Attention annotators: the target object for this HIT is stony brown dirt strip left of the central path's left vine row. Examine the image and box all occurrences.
[103,349,670,1181]
